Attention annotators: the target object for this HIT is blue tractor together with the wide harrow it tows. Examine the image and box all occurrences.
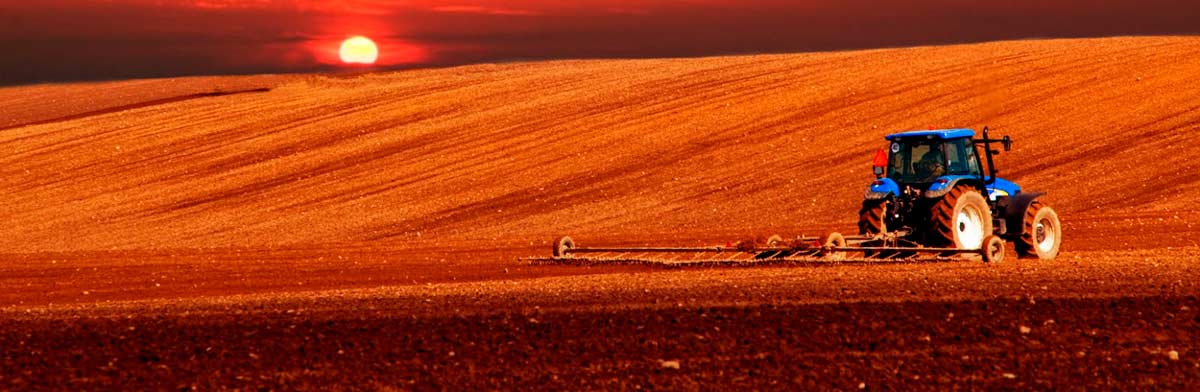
[528,127,1062,266]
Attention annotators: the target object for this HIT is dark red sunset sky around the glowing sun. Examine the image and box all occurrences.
[0,0,1200,84]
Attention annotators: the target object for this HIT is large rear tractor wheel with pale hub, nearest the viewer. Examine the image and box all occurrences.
[930,186,992,249]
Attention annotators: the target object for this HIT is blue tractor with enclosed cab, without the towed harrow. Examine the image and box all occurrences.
[858,127,1062,260]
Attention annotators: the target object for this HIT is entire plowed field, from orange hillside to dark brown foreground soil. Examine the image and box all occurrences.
[0,37,1200,390]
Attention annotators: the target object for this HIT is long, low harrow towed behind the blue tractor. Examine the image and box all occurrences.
[523,233,1004,267]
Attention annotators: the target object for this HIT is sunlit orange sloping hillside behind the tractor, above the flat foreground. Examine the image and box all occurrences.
[0,37,1200,252]
